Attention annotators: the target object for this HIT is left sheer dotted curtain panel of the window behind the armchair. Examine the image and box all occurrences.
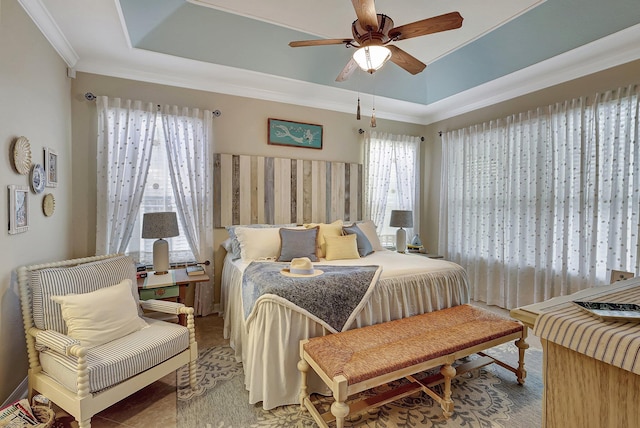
[96,96,157,255]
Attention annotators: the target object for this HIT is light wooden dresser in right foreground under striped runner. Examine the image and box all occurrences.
[511,278,640,428]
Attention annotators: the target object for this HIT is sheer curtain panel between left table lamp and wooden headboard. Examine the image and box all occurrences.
[162,106,214,316]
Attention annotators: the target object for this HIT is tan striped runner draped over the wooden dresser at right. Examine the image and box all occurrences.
[533,284,640,374]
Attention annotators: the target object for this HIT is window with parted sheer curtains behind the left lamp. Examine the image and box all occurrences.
[96,96,214,315]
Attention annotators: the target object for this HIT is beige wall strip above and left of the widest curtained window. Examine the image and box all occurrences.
[422,61,640,252]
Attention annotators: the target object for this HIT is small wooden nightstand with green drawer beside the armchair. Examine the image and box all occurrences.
[138,268,210,325]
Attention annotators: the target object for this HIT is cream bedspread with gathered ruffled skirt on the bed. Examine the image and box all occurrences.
[221,250,469,410]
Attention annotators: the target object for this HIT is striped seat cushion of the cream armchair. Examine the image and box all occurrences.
[39,318,189,393]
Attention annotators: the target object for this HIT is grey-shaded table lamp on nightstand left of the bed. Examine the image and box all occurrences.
[142,212,180,275]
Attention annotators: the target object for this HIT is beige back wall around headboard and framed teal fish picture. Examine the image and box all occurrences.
[71,73,424,308]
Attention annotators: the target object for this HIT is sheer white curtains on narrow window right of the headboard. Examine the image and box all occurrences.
[364,131,420,241]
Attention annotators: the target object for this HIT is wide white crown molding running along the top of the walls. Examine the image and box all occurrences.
[23,0,640,125]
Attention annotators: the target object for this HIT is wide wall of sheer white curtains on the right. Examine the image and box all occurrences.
[440,87,640,308]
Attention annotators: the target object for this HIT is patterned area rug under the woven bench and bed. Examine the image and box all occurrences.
[177,344,542,428]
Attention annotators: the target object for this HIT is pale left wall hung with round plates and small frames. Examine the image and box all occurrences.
[0,0,73,404]
